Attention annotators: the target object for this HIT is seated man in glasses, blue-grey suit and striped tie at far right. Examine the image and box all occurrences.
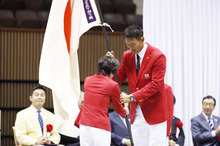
[191,95,220,146]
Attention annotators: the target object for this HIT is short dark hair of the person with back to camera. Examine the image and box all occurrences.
[97,56,119,75]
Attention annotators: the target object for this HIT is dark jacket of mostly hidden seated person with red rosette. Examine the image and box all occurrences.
[169,116,185,146]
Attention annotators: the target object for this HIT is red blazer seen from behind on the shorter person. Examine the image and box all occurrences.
[75,73,126,131]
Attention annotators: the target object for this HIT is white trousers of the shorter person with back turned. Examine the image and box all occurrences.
[80,125,111,146]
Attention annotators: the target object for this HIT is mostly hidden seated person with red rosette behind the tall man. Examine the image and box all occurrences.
[168,96,185,146]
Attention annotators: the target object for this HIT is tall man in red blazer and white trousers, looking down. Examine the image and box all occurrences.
[107,25,168,146]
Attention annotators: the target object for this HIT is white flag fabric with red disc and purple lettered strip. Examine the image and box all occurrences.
[39,0,100,137]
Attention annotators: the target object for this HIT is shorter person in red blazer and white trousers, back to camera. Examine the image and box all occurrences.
[75,56,128,146]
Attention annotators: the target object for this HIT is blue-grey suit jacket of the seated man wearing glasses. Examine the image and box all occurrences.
[191,113,220,146]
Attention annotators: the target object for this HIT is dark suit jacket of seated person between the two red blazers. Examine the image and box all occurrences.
[109,112,130,146]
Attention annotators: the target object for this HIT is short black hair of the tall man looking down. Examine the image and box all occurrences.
[124,24,143,40]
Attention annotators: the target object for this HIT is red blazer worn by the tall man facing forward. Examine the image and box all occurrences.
[117,44,167,125]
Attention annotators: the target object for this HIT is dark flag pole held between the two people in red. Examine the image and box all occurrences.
[95,0,134,146]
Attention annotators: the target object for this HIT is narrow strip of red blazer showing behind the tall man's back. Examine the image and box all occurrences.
[165,84,174,136]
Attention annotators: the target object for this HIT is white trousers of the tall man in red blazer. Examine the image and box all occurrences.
[131,105,167,146]
